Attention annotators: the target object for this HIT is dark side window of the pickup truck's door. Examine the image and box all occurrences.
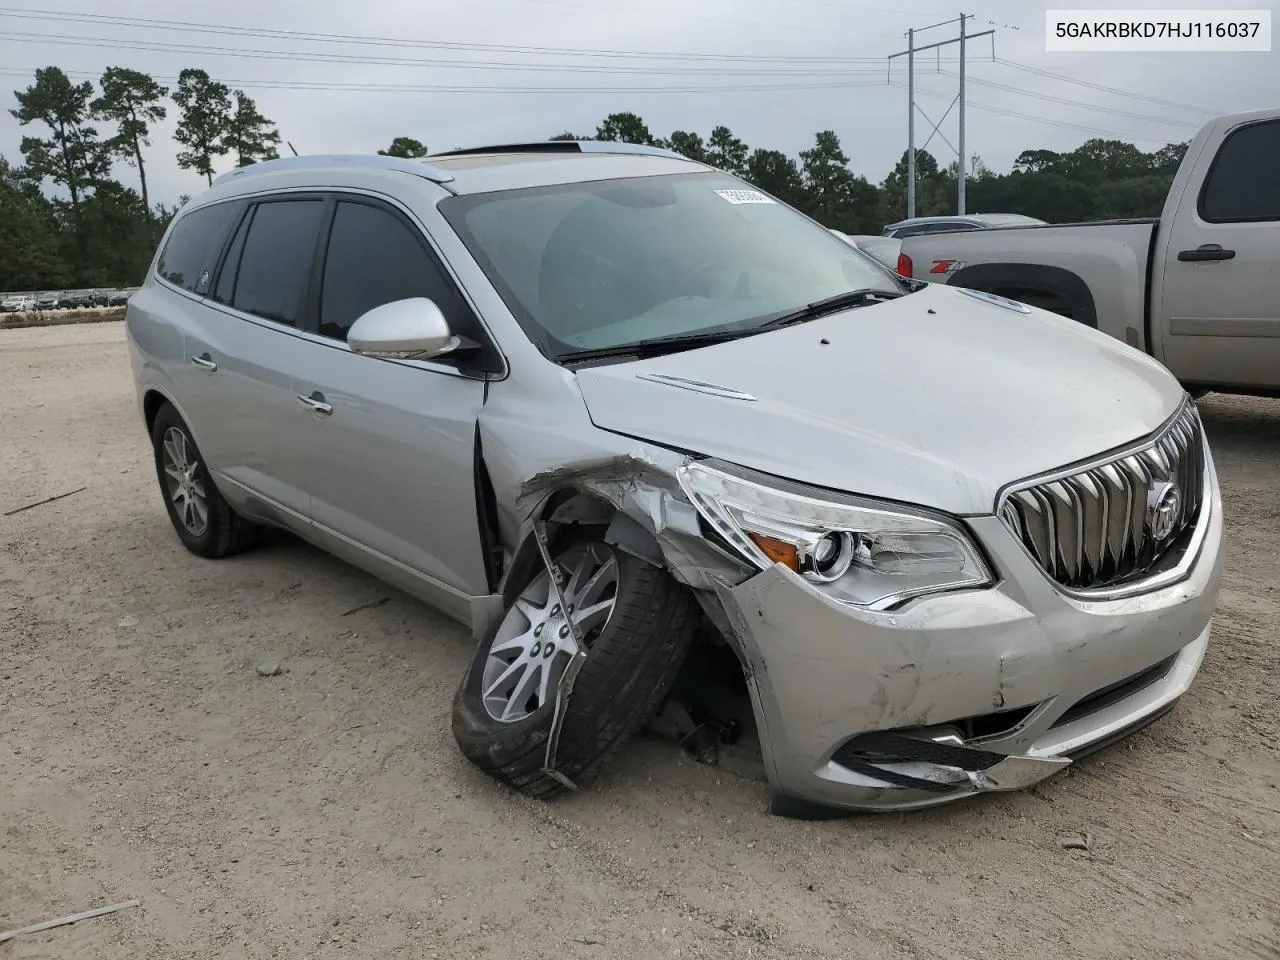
[1199,120,1280,223]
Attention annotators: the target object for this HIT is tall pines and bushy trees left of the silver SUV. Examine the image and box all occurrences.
[0,67,280,291]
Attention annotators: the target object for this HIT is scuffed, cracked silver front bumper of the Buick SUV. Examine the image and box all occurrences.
[717,496,1222,812]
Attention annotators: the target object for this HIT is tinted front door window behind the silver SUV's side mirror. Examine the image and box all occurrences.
[320,202,458,340]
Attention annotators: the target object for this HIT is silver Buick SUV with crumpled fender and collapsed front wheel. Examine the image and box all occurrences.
[127,142,1222,815]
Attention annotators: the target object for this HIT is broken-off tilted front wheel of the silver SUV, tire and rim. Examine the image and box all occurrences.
[453,535,698,799]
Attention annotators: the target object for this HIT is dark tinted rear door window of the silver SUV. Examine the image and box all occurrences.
[232,200,324,326]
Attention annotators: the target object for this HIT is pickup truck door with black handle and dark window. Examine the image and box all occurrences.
[1152,119,1280,387]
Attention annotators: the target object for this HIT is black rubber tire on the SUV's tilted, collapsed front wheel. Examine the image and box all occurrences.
[453,536,698,799]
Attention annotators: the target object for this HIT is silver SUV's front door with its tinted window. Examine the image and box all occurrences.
[294,195,489,596]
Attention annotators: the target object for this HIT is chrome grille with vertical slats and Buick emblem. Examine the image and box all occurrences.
[1000,402,1204,590]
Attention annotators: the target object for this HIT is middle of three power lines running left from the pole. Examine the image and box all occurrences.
[0,31,901,77]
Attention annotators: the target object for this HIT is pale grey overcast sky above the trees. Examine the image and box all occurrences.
[0,0,1280,202]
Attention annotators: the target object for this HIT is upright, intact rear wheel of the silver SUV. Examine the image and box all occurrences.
[151,403,262,559]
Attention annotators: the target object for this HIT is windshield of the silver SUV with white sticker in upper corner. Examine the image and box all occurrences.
[440,173,904,357]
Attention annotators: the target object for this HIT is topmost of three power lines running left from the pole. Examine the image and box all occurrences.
[0,8,901,64]
